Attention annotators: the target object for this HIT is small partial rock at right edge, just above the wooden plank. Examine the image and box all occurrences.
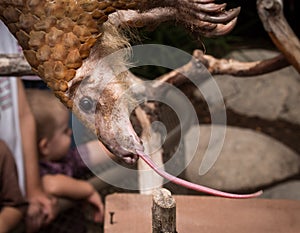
[261,180,300,200]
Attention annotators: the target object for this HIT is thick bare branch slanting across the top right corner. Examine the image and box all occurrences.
[257,0,300,73]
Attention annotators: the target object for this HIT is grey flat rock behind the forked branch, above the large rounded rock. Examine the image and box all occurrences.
[203,49,300,124]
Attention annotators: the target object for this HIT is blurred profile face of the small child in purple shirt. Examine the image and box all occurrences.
[47,111,72,161]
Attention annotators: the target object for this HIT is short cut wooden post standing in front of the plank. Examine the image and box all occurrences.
[152,188,176,233]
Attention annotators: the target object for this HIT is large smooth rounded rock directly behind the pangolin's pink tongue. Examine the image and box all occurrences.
[184,125,300,191]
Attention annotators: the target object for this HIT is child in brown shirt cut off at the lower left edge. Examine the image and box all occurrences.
[0,140,27,233]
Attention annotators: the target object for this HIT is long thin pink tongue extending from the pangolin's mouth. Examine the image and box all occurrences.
[136,150,262,199]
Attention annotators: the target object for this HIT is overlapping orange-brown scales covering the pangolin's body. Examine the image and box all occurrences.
[0,0,146,108]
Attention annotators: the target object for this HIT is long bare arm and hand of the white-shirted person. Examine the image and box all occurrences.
[18,79,55,227]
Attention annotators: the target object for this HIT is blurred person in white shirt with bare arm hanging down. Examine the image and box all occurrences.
[0,21,55,232]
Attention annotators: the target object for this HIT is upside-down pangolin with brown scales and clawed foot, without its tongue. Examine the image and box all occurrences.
[0,0,262,198]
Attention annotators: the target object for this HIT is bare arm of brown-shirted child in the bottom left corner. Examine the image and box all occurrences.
[0,207,23,233]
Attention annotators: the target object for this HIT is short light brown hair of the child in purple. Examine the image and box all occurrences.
[26,89,68,141]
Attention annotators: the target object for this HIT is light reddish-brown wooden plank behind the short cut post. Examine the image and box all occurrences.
[104,194,300,233]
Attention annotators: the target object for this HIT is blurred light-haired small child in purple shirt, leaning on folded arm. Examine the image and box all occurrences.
[27,89,111,232]
